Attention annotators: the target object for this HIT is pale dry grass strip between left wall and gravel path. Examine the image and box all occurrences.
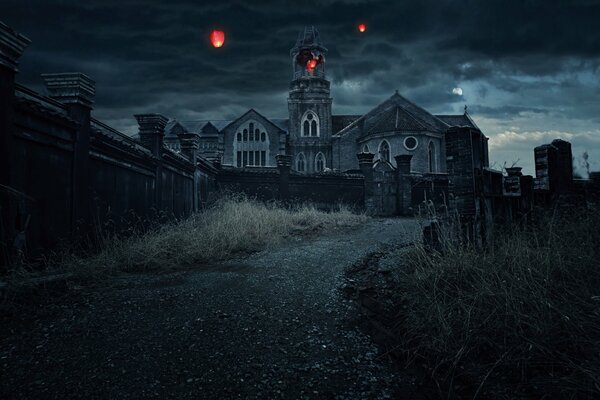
[60,197,367,276]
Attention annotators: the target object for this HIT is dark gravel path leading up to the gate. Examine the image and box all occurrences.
[0,219,417,399]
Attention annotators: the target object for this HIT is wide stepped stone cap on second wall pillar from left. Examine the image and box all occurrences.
[42,72,96,108]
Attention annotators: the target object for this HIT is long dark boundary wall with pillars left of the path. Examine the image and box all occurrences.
[0,24,217,265]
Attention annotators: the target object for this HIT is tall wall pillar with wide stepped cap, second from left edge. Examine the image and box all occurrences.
[42,72,96,233]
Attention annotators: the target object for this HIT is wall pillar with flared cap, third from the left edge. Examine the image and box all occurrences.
[134,114,168,211]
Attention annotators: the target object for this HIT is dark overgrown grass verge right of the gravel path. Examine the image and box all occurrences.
[394,212,600,399]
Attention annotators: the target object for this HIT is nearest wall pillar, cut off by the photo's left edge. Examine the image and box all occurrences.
[0,22,31,266]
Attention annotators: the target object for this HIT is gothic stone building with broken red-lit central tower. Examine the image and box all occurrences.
[165,27,480,174]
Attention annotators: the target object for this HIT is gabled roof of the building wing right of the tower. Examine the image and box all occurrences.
[336,92,448,135]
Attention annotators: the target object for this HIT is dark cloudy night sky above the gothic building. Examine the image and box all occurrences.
[0,0,600,176]
